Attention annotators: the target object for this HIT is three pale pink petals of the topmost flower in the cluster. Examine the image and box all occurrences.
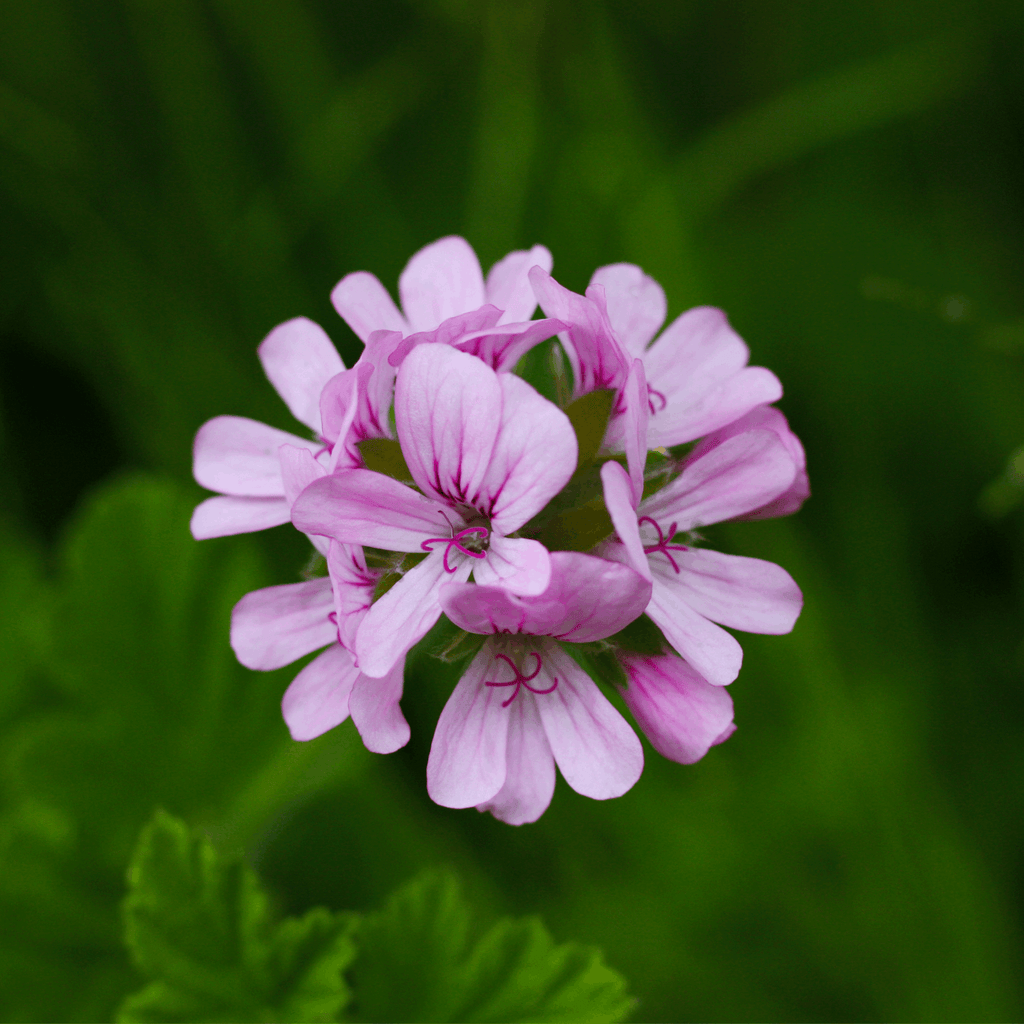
[331,234,551,341]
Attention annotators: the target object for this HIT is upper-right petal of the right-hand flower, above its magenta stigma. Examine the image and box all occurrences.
[639,430,797,530]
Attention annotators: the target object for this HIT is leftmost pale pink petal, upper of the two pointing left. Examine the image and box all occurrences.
[193,416,323,498]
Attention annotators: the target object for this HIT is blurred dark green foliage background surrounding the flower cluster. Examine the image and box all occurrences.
[0,0,1024,1021]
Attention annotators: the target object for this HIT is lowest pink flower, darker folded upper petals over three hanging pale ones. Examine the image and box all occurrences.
[427,551,650,824]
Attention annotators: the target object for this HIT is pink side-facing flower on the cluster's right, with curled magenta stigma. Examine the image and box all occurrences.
[600,429,803,685]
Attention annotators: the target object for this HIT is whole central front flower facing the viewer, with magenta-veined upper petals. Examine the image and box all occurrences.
[292,345,577,676]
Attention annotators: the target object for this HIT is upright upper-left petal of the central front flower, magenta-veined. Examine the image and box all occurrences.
[393,345,501,505]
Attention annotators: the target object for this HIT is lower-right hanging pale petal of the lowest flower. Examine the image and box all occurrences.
[534,643,643,800]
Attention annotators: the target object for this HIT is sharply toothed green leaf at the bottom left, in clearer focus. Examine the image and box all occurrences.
[118,811,354,1022]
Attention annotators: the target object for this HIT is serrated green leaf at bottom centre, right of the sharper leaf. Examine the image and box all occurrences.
[350,871,632,1022]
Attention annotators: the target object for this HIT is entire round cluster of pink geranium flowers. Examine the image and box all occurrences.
[191,238,809,824]
